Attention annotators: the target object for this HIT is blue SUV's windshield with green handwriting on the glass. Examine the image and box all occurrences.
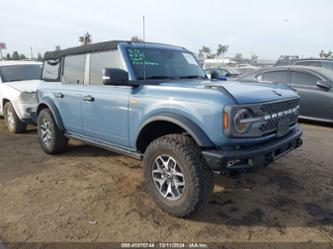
[127,48,205,80]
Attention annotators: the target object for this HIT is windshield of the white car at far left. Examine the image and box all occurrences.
[0,64,42,82]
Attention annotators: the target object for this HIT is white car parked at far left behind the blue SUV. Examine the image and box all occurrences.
[0,61,42,133]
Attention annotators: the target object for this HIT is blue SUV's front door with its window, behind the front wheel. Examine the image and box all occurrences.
[82,50,132,147]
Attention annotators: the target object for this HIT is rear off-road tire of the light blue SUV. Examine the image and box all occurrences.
[37,108,68,154]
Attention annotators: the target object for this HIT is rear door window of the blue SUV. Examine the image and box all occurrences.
[62,54,86,84]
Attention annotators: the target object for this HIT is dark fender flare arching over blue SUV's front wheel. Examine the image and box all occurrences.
[135,112,216,148]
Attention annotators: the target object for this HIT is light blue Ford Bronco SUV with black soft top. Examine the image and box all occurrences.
[37,41,302,216]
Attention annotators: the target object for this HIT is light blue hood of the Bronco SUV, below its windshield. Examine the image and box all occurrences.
[161,80,298,104]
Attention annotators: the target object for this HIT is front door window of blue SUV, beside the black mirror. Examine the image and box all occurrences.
[89,50,123,85]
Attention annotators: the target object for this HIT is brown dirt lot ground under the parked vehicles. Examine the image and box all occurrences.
[0,119,333,242]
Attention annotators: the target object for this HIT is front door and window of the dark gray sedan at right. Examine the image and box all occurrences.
[290,70,333,119]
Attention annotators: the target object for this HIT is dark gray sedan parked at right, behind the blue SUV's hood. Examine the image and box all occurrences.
[237,66,333,123]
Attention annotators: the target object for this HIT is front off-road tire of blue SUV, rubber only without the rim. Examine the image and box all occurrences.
[143,134,214,217]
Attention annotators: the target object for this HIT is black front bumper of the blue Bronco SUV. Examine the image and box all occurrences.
[202,127,303,171]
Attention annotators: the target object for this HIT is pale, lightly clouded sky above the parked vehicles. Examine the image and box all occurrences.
[0,0,333,59]
